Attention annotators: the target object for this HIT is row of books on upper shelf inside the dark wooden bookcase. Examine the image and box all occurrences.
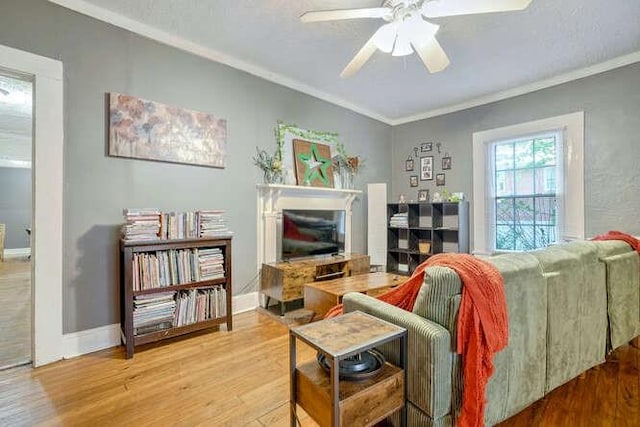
[132,248,225,291]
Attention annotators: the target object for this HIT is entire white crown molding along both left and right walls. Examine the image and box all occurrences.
[48,0,640,126]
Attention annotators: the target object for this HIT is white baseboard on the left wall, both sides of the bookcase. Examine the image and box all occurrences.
[62,292,258,359]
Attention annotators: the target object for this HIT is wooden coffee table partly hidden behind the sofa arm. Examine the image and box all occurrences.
[304,273,409,317]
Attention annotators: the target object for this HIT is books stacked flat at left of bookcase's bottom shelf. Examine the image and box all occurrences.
[133,292,176,335]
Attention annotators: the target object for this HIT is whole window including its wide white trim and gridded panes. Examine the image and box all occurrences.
[472,112,584,254]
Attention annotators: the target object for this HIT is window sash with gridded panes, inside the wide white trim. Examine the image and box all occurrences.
[489,132,562,251]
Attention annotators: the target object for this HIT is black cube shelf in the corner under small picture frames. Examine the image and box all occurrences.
[387,201,469,275]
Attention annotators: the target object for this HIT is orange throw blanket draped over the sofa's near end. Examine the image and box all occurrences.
[325,254,509,427]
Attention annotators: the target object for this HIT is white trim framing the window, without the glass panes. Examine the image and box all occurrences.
[472,111,584,255]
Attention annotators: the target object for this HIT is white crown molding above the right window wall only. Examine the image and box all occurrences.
[389,51,640,126]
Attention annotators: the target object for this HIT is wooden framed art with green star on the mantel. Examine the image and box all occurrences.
[293,139,333,188]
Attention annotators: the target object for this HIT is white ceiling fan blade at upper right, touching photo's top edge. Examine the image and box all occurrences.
[422,0,531,18]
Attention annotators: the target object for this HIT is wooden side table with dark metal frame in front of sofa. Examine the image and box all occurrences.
[289,311,407,427]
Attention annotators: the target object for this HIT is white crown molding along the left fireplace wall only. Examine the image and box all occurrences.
[49,0,391,124]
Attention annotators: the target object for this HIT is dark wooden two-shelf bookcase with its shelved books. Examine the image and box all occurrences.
[120,237,232,359]
